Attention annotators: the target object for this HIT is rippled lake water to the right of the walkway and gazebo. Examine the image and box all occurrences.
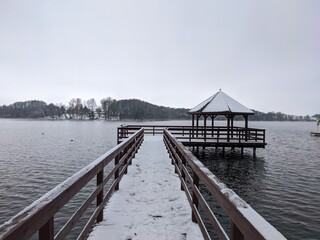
[193,122,320,239]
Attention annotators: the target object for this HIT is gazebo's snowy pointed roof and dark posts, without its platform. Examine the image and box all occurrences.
[188,89,254,137]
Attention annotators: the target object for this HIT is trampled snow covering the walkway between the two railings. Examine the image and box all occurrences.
[88,136,203,240]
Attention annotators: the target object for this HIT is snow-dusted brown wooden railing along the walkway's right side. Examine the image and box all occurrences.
[164,130,285,240]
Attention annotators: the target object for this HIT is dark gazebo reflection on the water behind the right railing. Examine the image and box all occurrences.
[190,148,265,239]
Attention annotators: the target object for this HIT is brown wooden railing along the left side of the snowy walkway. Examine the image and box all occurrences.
[0,129,144,240]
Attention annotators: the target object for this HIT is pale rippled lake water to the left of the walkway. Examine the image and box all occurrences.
[0,119,122,239]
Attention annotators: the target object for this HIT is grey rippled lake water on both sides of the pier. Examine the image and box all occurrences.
[0,119,320,239]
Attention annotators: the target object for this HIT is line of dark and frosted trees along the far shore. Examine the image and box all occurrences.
[0,97,320,121]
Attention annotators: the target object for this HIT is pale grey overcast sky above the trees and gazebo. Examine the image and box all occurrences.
[0,0,320,115]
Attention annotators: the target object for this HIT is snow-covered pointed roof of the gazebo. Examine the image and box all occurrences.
[188,90,254,115]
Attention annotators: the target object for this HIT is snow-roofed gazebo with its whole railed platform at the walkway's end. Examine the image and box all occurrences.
[118,90,266,156]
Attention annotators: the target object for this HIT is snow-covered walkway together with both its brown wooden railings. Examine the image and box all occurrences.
[0,128,285,240]
